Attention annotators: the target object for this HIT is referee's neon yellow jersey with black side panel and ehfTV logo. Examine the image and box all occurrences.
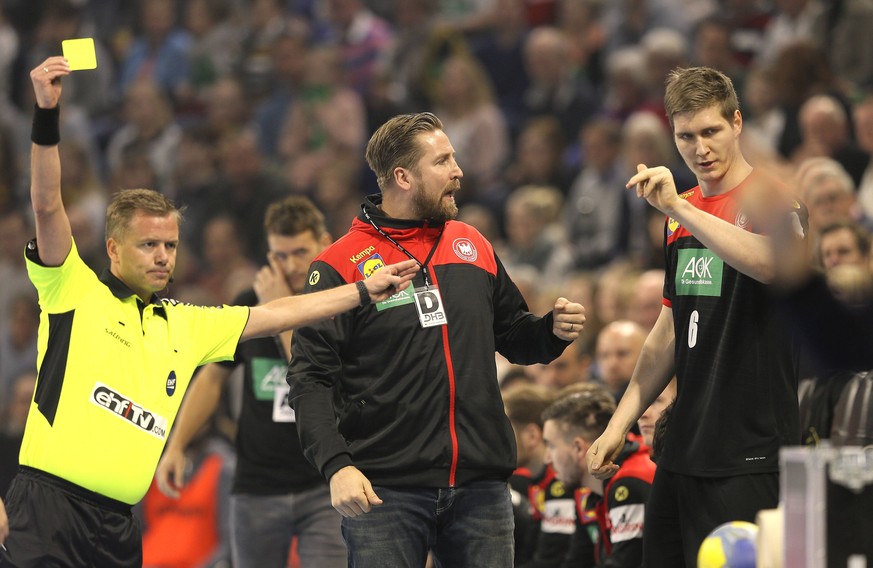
[20,241,249,505]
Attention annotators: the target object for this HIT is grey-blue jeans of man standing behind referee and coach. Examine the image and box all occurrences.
[230,485,346,568]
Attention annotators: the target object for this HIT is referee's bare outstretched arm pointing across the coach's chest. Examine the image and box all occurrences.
[241,260,418,340]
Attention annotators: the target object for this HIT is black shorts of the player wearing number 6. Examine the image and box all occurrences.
[643,467,779,568]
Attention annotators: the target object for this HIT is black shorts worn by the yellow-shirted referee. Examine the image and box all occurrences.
[0,467,142,568]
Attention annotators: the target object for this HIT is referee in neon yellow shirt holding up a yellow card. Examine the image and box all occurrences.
[0,57,418,568]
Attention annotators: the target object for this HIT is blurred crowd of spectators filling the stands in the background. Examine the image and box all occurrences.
[0,0,873,566]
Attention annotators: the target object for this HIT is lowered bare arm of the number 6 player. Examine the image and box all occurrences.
[586,306,676,479]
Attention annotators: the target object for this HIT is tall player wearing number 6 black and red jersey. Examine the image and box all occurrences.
[587,67,806,568]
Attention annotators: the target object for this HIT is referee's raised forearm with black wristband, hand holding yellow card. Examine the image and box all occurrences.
[30,57,73,266]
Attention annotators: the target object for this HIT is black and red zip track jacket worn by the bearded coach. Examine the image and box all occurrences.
[287,195,568,487]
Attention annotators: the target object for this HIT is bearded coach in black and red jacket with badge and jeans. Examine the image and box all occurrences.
[288,113,585,568]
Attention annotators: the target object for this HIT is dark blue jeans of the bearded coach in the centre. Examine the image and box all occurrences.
[342,481,514,568]
